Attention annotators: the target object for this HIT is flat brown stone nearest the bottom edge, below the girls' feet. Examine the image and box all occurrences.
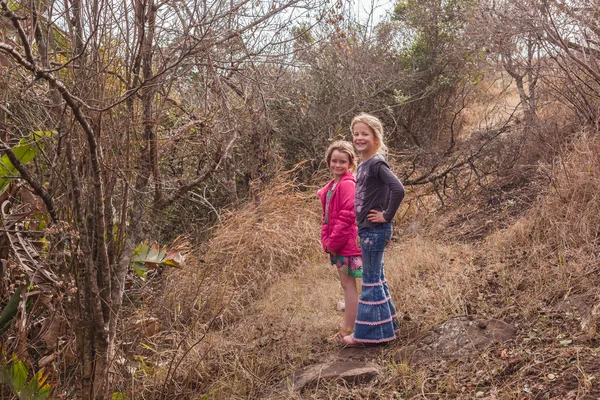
[293,361,380,391]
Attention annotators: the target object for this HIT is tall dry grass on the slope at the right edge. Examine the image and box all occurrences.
[485,130,600,324]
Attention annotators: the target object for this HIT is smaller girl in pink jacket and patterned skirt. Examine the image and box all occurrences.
[317,141,362,344]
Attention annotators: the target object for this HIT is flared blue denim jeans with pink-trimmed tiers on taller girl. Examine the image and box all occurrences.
[354,222,398,343]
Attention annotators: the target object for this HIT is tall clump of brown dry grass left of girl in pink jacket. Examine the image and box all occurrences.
[157,178,320,327]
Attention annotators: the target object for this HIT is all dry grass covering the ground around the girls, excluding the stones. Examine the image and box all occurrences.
[113,130,600,399]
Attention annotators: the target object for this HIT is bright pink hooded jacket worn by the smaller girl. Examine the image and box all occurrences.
[317,172,361,256]
